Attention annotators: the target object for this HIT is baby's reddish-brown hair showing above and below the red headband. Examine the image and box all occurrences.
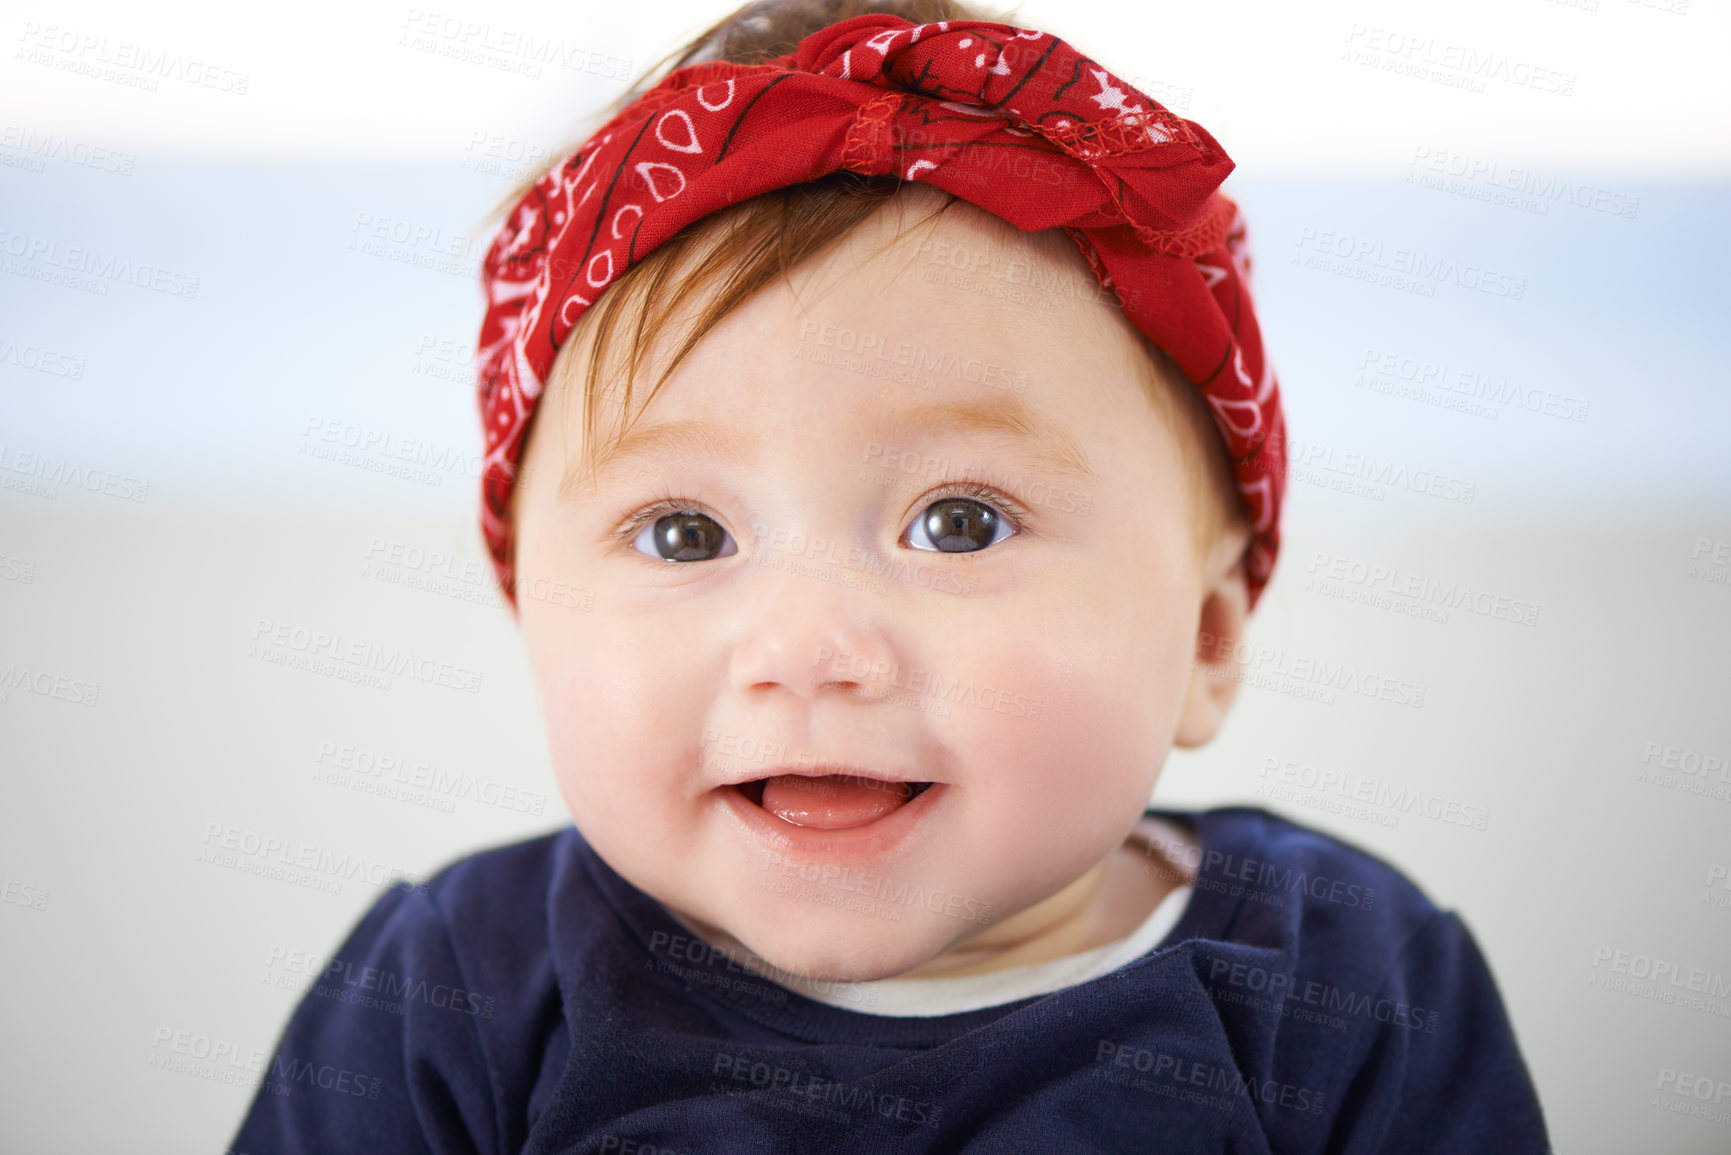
[504,0,1243,564]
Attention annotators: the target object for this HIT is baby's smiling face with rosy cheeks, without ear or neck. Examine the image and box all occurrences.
[516,194,1232,980]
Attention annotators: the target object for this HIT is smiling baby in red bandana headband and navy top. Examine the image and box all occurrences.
[232,0,1546,1155]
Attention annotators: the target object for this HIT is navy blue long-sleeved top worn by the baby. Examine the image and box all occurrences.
[232,807,1548,1155]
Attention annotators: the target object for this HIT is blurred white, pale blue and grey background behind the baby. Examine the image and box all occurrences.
[0,0,1731,1155]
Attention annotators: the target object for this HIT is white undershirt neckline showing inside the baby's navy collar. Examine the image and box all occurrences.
[769,816,1196,1018]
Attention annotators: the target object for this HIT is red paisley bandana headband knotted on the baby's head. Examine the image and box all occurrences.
[476,16,1286,606]
